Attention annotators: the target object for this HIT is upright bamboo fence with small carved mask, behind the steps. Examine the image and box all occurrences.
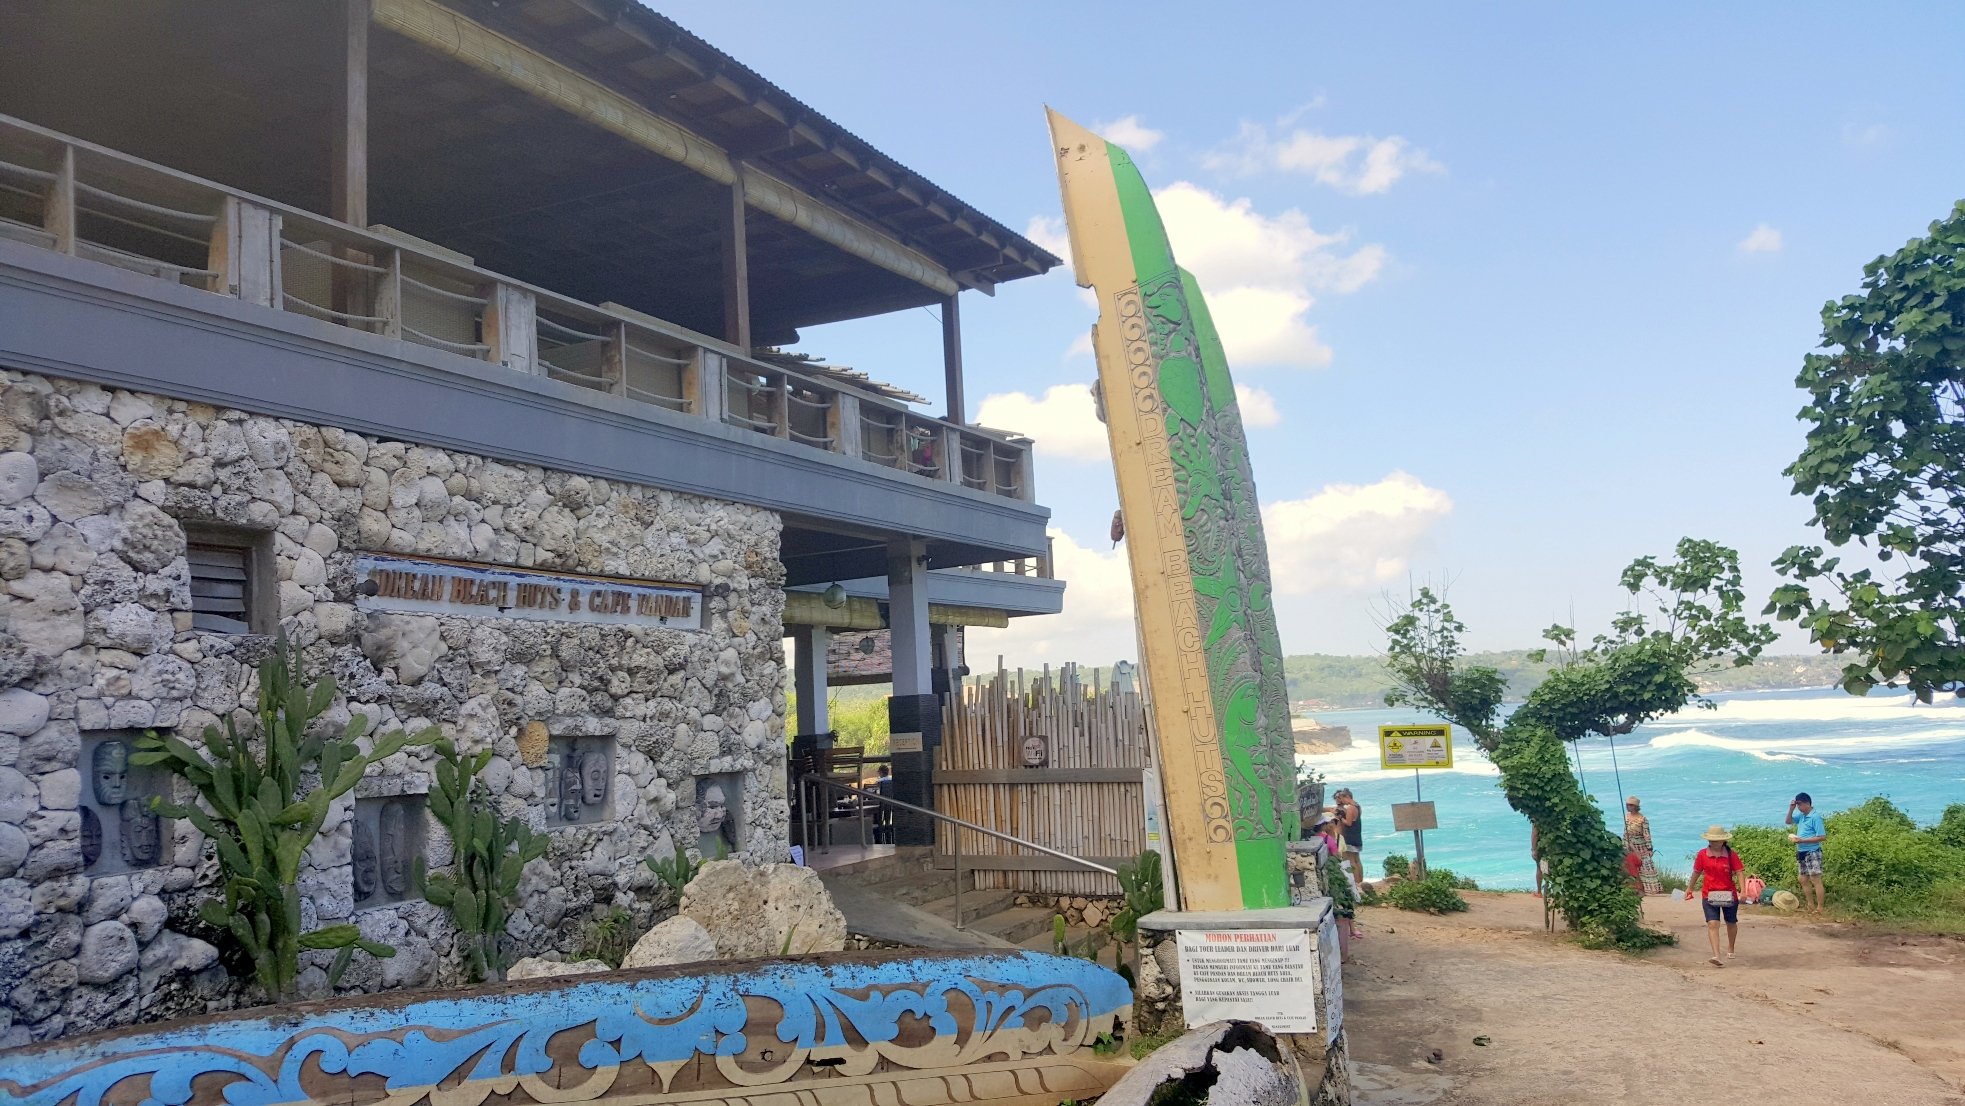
[935,662,1151,896]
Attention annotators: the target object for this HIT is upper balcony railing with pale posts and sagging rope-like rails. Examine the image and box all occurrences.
[0,116,1034,501]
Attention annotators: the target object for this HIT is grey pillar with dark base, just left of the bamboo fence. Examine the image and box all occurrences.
[886,540,941,845]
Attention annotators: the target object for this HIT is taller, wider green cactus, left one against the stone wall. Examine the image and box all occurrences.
[130,638,436,1002]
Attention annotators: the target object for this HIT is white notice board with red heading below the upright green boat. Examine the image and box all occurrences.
[1175,929,1317,1033]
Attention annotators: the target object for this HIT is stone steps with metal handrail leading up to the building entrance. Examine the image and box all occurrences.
[819,847,1110,953]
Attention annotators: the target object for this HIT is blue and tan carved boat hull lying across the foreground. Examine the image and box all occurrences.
[0,953,1132,1106]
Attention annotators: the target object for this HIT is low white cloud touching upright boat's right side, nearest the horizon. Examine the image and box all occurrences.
[1262,471,1454,595]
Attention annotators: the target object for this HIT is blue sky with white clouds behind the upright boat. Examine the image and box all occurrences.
[662,2,1965,664]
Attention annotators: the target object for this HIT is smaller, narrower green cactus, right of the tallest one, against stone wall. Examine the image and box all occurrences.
[417,737,546,982]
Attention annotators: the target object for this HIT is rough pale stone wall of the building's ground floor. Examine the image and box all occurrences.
[0,371,786,1045]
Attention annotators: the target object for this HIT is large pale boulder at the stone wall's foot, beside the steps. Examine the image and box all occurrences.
[682,860,847,959]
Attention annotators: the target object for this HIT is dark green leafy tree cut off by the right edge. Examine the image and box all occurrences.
[1767,200,1965,701]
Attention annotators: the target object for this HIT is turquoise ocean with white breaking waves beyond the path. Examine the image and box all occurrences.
[1297,688,1965,888]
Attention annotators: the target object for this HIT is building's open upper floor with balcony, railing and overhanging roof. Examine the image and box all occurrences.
[0,0,1059,589]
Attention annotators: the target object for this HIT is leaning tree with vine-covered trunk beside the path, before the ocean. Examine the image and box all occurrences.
[1385,538,1774,947]
